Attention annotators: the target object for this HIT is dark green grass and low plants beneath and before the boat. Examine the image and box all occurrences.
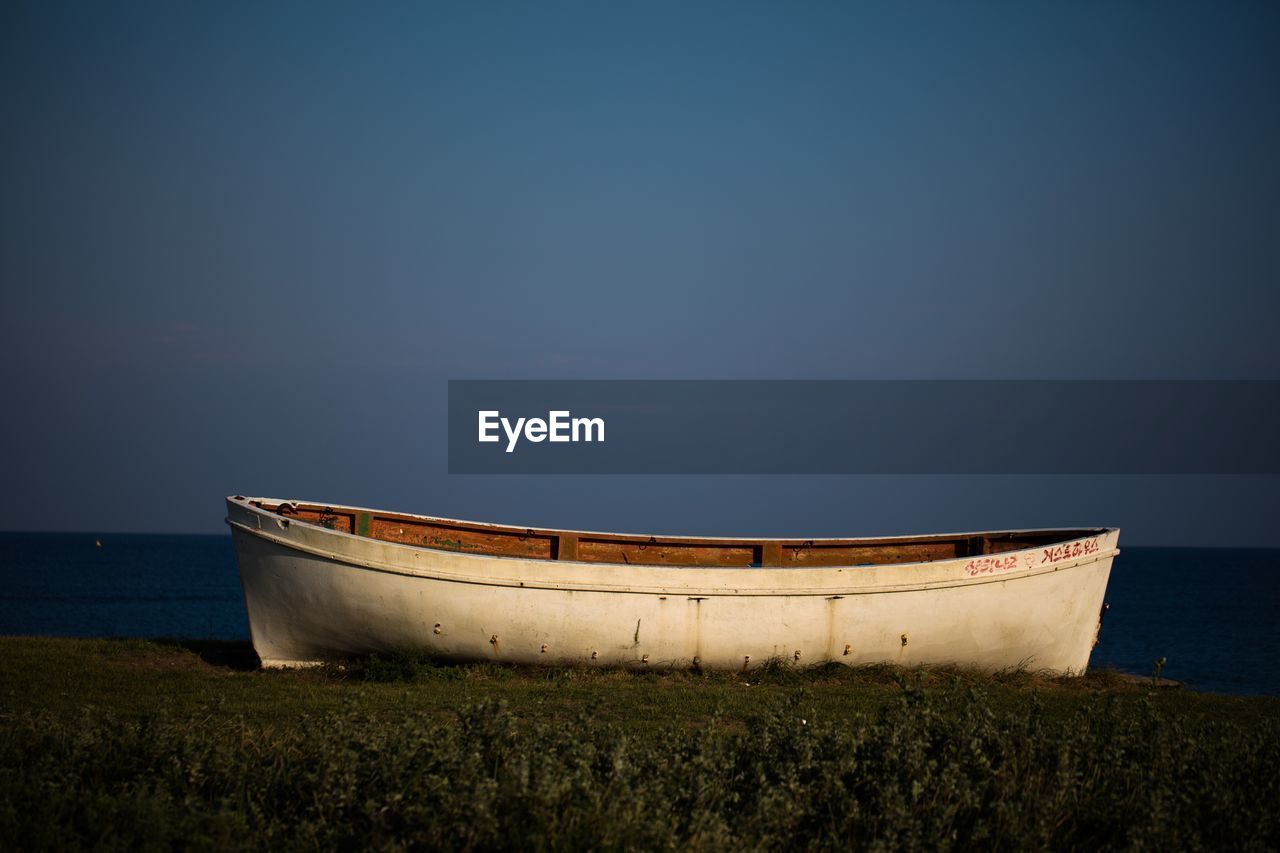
[0,638,1280,849]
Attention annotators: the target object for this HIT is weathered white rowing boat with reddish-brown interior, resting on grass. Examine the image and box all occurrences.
[227,496,1120,674]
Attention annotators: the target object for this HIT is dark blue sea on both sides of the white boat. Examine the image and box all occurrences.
[0,533,1280,695]
